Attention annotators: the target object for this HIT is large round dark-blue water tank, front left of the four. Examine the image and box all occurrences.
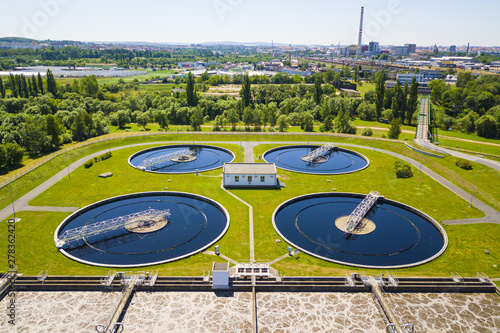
[54,192,229,267]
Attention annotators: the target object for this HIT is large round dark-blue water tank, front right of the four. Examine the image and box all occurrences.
[273,193,448,268]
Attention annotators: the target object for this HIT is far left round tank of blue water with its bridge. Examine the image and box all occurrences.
[128,144,234,173]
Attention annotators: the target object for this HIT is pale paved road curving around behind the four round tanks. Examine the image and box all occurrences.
[0,141,500,224]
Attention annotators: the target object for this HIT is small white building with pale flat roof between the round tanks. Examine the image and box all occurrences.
[222,163,278,188]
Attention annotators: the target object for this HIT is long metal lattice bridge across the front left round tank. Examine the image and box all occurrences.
[56,209,170,249]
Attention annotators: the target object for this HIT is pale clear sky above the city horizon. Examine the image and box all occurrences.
[0,0,500,46]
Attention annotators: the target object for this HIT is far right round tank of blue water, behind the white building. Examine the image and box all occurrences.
[263,145,370,175]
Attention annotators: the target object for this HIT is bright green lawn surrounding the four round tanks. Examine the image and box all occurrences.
[0,132,500,277]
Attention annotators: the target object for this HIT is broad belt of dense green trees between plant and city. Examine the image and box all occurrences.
[0,62,500,169]
